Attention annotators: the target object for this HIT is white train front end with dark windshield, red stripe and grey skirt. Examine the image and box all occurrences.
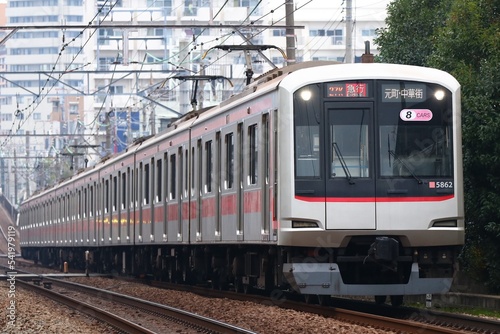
[277,64,464,298]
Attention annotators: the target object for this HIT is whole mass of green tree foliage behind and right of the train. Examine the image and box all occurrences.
[376,0,500,292]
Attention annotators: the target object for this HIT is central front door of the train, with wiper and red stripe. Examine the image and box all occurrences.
[324,102,376,229]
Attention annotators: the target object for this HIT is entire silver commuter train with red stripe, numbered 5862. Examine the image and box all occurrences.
[19,62,464,305]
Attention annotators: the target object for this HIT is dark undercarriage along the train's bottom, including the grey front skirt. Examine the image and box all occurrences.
[22,237,458,306]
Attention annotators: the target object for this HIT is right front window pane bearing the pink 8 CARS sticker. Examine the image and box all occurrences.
[377,81,453,180]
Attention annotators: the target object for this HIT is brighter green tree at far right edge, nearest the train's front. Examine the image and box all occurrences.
[427,0,500,292]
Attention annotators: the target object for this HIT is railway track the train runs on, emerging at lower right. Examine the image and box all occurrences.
[137,281,500,334]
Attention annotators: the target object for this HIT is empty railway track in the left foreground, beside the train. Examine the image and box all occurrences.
[18,278,254,334]
